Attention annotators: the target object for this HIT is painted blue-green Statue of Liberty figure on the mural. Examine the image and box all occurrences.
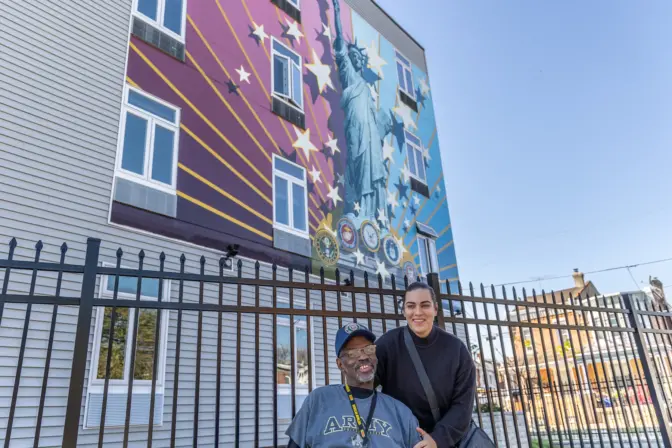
[333,0,392,222]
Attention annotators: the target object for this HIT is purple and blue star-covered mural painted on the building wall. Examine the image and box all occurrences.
[111,0,457,279]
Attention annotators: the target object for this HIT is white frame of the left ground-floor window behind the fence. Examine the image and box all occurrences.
[84,263,170,429]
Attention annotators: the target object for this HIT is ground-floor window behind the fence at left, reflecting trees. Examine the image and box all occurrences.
[84,268,170,428]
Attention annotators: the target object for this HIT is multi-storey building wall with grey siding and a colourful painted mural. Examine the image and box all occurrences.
[0,0,458,446]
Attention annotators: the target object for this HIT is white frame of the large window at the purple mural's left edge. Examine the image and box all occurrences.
[115,85,181,194]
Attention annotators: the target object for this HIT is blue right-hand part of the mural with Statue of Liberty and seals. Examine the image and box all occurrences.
[315,0,458,280]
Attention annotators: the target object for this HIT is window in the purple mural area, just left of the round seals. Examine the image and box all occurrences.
[273,155,308,238]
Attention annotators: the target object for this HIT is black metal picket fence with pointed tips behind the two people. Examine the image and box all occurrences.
[0,239,672,448]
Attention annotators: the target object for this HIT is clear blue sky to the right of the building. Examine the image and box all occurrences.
[378,0,672,295]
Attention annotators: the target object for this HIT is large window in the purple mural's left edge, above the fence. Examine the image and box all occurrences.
[117,87,180,193]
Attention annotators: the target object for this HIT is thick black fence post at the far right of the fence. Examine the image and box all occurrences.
[623,294,672,448]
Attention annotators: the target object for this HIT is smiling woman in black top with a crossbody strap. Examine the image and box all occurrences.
[376,282,476,448]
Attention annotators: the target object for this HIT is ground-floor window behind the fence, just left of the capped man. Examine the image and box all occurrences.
[275,297,315,422]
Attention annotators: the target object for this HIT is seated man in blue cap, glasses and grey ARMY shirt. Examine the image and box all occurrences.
[286,322,421,448]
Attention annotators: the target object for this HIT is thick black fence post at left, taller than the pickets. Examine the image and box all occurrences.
[63,238,100,448]
